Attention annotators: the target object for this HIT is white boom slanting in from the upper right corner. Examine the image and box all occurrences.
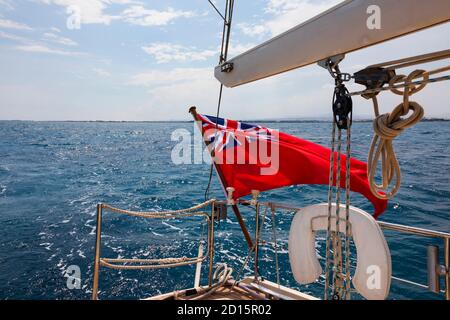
[215,0,450,87]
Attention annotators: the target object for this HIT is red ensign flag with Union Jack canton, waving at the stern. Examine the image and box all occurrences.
[197,114,387,217]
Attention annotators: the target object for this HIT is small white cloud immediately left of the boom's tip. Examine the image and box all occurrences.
[142,42,217,63]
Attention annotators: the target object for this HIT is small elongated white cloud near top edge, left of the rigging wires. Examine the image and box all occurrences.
[122,6,196,27]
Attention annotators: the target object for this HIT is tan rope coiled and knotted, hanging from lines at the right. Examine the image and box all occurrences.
[364,50,450,199]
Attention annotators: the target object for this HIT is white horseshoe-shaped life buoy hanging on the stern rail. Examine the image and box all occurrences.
[289,204,392,300]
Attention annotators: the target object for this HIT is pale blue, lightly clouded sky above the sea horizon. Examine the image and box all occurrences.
[0,0,450,121]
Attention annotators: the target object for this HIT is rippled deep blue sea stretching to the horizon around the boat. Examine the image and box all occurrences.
[0,121,450,299]
